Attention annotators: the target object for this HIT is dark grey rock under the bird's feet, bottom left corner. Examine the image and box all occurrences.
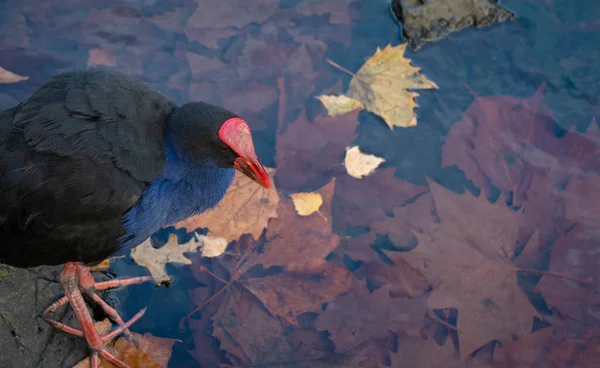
[0,265,100,368]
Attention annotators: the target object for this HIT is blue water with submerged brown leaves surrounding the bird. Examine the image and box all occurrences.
[0,0,600,367]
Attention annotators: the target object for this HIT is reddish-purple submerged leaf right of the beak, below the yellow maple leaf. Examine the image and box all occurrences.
[275,111,358,192]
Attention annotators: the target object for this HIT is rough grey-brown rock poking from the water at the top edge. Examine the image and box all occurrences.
[391,0,514,50]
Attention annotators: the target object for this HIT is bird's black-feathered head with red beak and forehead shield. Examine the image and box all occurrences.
[169,102,270,188]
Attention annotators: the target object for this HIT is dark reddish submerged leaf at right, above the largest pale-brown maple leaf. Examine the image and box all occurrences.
[442,84,572,246]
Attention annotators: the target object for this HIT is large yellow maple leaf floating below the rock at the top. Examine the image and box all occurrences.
[317,43,439,128]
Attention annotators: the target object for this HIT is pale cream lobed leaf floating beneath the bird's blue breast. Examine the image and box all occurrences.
[131,234,227,284]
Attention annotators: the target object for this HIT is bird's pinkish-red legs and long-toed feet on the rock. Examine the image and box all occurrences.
[42,262,152,368]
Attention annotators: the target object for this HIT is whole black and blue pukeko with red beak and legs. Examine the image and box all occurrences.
[0,70,270,368]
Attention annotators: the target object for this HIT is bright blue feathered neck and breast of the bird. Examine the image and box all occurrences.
[122,139,235,250]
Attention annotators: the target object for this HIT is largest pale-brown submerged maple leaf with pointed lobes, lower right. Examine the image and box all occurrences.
[384,181,538,358]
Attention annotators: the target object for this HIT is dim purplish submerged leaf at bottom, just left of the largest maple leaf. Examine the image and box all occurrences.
[315,281,425,353]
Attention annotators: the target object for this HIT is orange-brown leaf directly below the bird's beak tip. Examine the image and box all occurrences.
[175,169,279,242]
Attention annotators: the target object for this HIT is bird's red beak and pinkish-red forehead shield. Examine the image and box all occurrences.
[219,118,271,189]
